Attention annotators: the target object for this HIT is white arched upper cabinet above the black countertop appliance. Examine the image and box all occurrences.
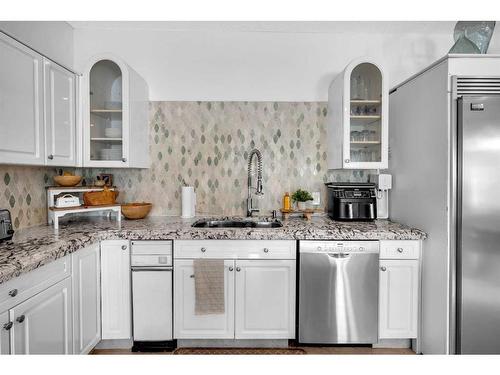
[327,59,389,169]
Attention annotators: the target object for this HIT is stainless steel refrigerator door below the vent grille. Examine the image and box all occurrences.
[457,97,500,354]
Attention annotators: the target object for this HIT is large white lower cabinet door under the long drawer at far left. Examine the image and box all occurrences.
[9,277,73,354]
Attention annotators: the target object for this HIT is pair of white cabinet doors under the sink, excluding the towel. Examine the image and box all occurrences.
[174,245,296,339]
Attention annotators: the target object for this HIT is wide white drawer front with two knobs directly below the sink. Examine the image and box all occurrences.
[174,240,296,259]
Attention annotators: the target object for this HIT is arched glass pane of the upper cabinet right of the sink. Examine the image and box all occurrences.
[349,63,382,163]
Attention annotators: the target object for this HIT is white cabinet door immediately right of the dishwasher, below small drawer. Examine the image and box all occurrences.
[379,259,419,339]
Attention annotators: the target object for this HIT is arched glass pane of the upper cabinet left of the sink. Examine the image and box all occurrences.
[88,60,124,162]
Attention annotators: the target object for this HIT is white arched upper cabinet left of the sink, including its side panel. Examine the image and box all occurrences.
[83,55,149,168]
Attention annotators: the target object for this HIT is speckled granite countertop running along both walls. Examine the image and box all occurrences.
[0,216,426,284]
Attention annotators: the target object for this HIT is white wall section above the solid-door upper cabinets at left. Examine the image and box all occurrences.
[0,21,74,68]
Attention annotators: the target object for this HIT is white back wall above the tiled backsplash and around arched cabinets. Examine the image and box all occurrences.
[72,22,500,101]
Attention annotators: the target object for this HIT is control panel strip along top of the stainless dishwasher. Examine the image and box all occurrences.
[299,241,379,253]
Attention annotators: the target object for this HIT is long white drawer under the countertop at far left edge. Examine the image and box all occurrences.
[0,256,71,311]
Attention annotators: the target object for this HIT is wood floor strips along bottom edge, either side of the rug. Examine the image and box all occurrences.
[90,346,415,355]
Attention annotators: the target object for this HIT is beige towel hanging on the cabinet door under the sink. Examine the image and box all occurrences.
[193,259,224,315]
